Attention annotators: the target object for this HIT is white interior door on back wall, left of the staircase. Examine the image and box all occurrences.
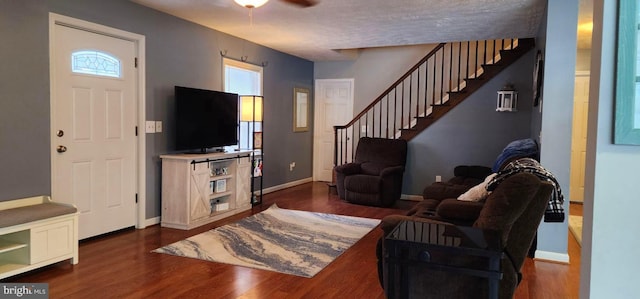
[313,79,354,182]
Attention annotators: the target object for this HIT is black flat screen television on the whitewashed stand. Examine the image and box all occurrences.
[175,86,238,153]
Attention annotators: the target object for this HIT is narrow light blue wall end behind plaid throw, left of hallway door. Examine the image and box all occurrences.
[534,0,578,260]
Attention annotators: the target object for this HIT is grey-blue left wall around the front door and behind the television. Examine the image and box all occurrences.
[0,0,313,218]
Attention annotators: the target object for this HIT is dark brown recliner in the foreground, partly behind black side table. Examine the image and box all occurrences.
[377,173,554,298]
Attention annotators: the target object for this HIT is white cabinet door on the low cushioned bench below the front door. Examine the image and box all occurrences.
[31,219,74,264]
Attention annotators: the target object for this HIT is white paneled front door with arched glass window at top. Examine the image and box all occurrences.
[51,25,137,239]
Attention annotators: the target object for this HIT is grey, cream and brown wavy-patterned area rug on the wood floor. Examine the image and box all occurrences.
[153,205,380,277]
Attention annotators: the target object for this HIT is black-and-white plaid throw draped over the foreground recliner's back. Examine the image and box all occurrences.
[487,158,565,222]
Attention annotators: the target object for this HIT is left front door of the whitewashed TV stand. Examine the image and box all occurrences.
[189,163,211,221]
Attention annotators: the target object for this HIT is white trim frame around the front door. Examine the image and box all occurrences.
[49,12,148,229]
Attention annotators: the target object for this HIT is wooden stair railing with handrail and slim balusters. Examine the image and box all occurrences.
[334,39,518,166]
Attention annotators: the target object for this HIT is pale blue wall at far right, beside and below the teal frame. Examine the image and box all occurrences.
[580,0,640,298]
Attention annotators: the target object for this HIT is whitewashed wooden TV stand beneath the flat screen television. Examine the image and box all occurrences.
[160,151,251,229]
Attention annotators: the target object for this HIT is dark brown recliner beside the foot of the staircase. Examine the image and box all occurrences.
[335,137,407,207]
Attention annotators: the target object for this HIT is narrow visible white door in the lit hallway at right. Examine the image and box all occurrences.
[570,73,589,202]
